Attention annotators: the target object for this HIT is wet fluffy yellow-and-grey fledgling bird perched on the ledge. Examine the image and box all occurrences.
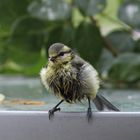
[40,43,119,120]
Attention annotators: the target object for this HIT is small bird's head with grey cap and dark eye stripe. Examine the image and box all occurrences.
[48,43,73,65]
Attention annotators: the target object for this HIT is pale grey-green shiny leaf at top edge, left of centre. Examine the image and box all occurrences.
[28,0,71,21]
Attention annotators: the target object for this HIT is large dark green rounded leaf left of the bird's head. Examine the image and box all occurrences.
[8,17,46,65]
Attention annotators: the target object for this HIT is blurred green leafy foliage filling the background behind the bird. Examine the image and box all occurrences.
[0,0,140,88]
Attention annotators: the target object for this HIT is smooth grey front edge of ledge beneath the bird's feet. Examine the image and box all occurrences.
[0,111,140,140]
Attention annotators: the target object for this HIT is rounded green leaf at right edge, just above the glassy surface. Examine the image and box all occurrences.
[109,53,140,83]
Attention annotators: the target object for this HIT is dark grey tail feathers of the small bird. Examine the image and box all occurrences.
[93,95,120,111]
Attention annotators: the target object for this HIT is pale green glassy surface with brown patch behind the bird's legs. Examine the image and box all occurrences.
[0,77,140,112]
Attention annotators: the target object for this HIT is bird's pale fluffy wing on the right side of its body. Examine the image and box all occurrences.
[73,56,100,99]
